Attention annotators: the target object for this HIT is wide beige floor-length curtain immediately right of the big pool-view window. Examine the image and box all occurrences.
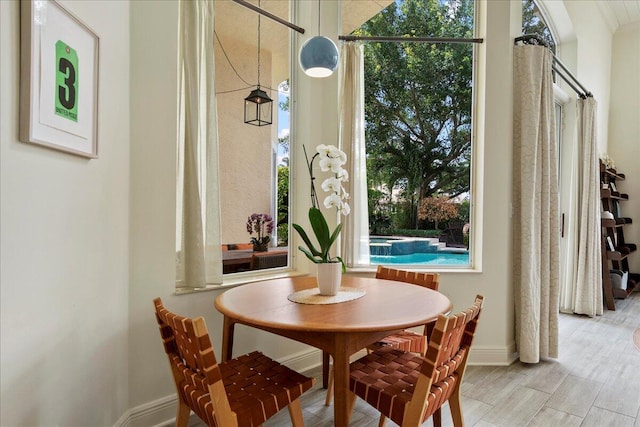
[513,46,560,363]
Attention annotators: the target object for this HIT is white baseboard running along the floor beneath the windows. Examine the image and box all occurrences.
[114,344,517,427]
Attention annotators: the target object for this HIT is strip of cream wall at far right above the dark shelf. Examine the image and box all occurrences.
[608,23,640,272]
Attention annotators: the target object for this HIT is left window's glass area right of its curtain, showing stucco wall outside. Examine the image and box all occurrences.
[214,1,291,274]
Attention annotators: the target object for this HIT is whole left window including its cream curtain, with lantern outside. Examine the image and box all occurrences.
[176,2,291,289]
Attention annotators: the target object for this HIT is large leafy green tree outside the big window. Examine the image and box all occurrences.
[362,0,473,231]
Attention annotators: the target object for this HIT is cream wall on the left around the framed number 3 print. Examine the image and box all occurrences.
[0,0,130,426]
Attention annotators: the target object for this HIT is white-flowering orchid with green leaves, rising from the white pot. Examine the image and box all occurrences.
[293,144,351,272]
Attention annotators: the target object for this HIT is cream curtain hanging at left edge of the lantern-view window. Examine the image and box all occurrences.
[176,0,222,288]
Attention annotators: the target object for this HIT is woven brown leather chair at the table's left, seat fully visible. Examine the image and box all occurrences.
[153,298,314,427]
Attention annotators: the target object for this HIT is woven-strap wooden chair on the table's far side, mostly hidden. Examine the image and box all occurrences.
[325,265,440,406]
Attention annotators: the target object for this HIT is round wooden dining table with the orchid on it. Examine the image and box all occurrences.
[214,275,452,427]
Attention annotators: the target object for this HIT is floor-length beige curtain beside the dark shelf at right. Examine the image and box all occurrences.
[573,97,603,316]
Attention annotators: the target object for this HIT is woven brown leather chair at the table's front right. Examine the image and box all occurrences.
[348,295,484,427]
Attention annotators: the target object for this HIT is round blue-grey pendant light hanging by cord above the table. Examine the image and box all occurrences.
[299,0,340,78]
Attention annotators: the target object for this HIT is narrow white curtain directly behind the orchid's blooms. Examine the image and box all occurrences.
[338,42,369,267]
